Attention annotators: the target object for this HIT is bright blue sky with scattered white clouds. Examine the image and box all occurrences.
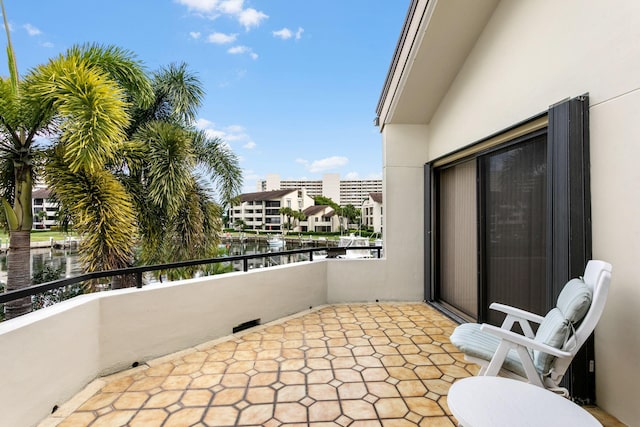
[0,0,409,191]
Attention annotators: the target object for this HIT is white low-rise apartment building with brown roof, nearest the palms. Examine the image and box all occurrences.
[229,188,313,231]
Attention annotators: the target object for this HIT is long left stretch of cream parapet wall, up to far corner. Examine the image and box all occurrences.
[0,261,330,426]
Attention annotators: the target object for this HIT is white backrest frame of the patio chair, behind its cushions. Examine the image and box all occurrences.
[551,260,612,383]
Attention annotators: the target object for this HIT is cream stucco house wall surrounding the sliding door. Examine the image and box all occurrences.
[383,0,640,425]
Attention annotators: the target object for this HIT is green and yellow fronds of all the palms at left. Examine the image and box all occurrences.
[0,28,242,294]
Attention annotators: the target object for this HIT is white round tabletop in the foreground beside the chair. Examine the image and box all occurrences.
[447,376,602,427]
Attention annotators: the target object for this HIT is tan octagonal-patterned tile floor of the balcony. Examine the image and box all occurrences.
[40,303,620,427]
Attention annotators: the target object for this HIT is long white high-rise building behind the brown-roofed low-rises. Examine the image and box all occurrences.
[257,173,382,206]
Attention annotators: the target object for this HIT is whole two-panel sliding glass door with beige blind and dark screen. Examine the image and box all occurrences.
[436,132,547,323]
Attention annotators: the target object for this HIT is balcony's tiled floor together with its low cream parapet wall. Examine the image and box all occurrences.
[0,259,616,427]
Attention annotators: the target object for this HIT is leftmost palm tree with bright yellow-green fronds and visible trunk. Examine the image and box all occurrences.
[0,0,150,318]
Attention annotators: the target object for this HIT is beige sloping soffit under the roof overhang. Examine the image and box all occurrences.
[378,0,499,127]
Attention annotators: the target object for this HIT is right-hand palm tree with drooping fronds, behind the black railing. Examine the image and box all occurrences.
[46,64,242,288]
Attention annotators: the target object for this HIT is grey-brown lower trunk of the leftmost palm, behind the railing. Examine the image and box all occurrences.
[4,231,31,319]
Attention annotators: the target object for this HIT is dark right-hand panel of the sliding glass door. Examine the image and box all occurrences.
[478,134,547,323]
